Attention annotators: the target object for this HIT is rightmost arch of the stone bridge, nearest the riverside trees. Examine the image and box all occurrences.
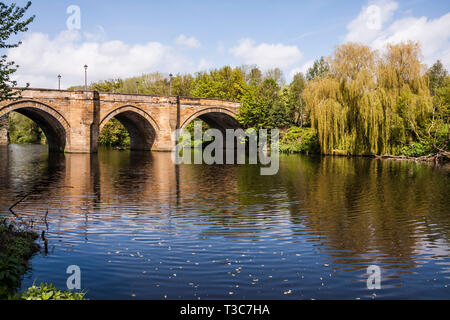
[181,107,241,131]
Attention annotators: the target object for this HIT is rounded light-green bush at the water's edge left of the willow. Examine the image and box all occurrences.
[280,127,320,154]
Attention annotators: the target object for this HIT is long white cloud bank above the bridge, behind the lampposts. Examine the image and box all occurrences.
[7,31,196,88]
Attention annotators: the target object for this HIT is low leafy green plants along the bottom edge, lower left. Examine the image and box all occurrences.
[15,283,86,300]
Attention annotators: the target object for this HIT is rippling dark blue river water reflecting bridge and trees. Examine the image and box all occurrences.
[0,146,450,299]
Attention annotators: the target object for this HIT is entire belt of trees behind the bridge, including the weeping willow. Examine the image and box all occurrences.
[62,42,450,155]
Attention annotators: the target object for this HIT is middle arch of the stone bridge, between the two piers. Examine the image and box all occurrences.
[99,105,159,150]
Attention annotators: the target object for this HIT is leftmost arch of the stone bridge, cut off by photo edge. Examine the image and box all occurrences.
[0,100,70,152]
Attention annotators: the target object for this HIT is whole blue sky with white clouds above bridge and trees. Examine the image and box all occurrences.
[4,0,450,88]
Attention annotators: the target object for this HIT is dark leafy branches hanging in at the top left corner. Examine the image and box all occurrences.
[0,1,34,101]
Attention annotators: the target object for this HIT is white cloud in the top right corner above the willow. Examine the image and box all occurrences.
[345,1,450,68]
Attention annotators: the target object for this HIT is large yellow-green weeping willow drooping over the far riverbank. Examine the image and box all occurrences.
[304,42,432,154]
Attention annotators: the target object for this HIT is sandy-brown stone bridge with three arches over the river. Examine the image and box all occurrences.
[0,89,240,153]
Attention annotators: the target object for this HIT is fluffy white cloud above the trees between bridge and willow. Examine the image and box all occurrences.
[230,39,303,69]
